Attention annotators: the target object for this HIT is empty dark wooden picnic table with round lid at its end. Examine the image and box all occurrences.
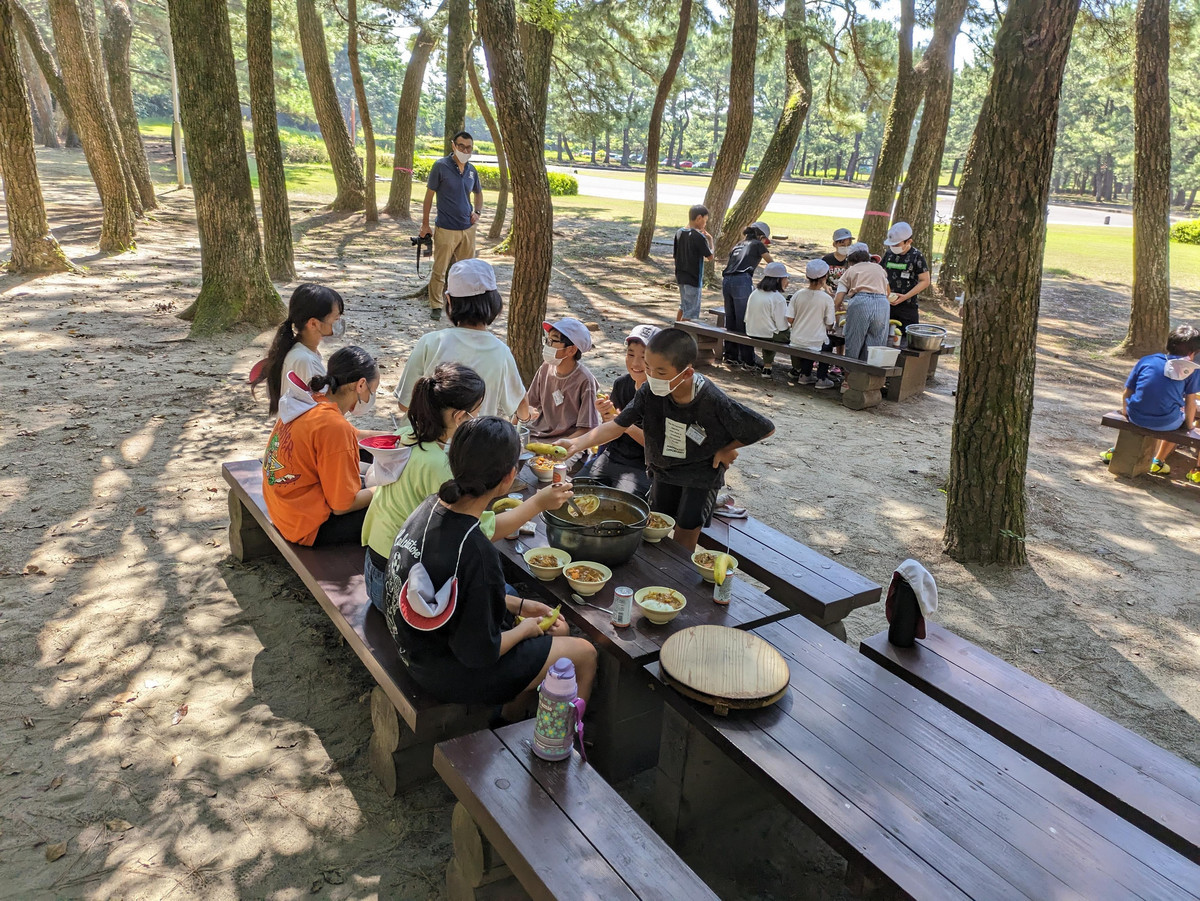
[648,617,1200,901]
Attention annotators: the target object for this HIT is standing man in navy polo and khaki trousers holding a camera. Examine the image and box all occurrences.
[421,132,484,319]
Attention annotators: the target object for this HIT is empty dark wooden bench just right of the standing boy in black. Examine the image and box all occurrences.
[700,516,883,641]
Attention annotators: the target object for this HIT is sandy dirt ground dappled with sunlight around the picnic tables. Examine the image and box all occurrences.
[0,151,1200,899]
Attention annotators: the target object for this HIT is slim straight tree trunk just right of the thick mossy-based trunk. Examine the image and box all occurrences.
[246,0,296,282]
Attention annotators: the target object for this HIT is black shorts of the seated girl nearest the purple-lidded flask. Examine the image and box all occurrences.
[408,635,554,707]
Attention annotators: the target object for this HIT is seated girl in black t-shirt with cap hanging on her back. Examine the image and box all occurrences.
[384,416,596,715]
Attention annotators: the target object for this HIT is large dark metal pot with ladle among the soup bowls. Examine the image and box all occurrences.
[541,479,650,566]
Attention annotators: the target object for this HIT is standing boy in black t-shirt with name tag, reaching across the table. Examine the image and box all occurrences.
[559,329,775,549]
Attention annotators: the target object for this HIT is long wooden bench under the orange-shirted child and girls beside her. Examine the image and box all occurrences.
[221,459,491,794]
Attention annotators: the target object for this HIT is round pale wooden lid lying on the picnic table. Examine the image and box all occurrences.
[659,626,791,702]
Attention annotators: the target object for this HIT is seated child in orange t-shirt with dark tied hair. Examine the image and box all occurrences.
[263,347,379,545]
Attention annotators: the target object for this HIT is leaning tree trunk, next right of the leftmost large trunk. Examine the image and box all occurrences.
[50,0,133,252]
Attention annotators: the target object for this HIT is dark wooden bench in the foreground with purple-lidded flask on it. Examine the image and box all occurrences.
[433,722,716,901]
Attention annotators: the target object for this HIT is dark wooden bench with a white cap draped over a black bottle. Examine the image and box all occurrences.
[859,623,1200,863]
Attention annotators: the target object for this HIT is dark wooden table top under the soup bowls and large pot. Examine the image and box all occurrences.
[496,473,792,666]
